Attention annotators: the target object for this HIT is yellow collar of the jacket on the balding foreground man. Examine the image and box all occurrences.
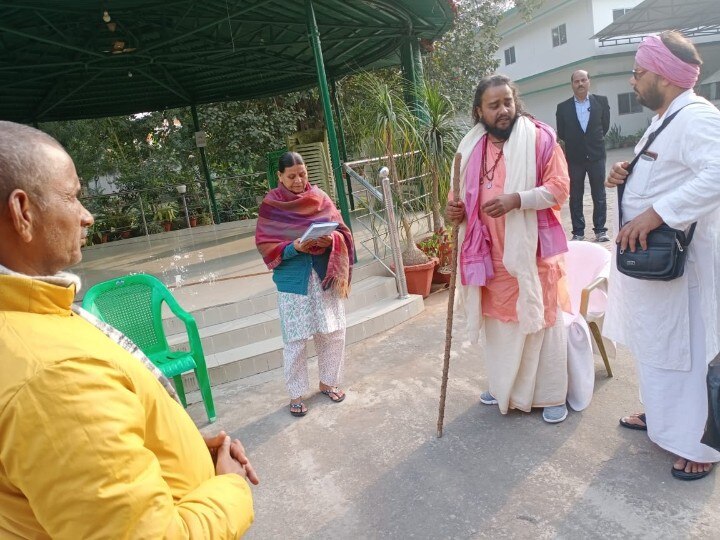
[0,274,75,316]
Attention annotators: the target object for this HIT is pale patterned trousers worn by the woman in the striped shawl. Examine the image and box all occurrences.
[283,328,345,399]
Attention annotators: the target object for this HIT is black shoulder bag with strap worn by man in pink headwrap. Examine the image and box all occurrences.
[617,105,696,281]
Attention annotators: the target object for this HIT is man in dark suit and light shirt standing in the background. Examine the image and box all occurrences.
[555,69,610,242]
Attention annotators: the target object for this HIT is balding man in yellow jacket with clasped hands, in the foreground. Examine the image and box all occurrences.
[0,122,258,540]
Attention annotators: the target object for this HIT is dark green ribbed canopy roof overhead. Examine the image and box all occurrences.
[0,0,454,122]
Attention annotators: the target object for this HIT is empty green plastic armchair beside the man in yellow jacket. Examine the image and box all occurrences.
[82,274,216,422]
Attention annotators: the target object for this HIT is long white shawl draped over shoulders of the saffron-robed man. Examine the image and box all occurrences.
[456,116,545,343]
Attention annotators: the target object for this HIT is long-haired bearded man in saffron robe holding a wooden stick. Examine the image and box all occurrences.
[446,75,569,423]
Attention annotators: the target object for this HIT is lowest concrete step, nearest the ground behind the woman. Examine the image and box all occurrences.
[183,295,425,401]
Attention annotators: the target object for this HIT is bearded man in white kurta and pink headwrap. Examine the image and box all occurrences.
[604,32,720,480]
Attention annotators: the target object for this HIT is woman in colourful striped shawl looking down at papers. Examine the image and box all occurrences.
[255,152,354,416]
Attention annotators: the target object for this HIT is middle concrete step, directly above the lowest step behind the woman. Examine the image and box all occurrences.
[168,276,397,355]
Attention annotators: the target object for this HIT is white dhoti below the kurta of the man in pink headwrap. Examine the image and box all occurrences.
[636,272,720,463]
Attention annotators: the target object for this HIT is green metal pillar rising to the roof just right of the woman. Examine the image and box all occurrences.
[305,0,352,229]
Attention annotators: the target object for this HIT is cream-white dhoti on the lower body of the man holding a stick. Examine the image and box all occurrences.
[483,310,568,414]
